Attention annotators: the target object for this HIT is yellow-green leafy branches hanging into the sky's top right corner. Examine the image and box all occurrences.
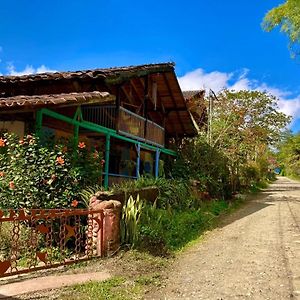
[262,0,300,57]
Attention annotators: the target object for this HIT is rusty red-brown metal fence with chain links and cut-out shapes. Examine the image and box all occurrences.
[0,209,104,277]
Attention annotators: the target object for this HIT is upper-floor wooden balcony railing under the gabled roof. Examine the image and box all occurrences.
[82,106,165,147]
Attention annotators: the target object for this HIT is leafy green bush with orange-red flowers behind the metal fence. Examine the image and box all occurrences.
[0,134,102,208]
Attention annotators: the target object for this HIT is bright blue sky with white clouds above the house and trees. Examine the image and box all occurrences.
[0,0,300,131]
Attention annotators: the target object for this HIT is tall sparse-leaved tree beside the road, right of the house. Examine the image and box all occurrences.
[210,90,290,188]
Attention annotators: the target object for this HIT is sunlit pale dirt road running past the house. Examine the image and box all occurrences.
[146,177,300,300]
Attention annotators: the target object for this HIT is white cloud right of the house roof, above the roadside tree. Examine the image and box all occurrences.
[178,69,300,126]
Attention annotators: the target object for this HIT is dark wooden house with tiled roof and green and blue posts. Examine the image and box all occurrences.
[0,63,197,187]
